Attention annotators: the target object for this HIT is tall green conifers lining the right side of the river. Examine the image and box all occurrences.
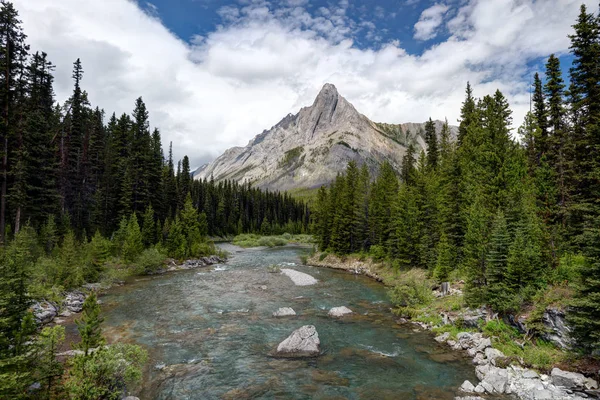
[313,6,600,350]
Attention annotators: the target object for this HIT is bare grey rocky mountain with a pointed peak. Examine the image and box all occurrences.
[194,83,457,190]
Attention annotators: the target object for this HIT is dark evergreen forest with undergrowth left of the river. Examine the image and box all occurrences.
[0,1,309,399]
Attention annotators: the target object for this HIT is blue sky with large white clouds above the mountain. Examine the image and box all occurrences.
[13,0,598,166]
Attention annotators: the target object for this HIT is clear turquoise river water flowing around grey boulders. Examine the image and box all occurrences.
[102,245,476,400]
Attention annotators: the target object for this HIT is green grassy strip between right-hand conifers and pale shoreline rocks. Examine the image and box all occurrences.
[307,252,598,377]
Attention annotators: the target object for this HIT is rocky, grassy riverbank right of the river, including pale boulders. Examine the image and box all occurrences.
[307,253,600,400]
